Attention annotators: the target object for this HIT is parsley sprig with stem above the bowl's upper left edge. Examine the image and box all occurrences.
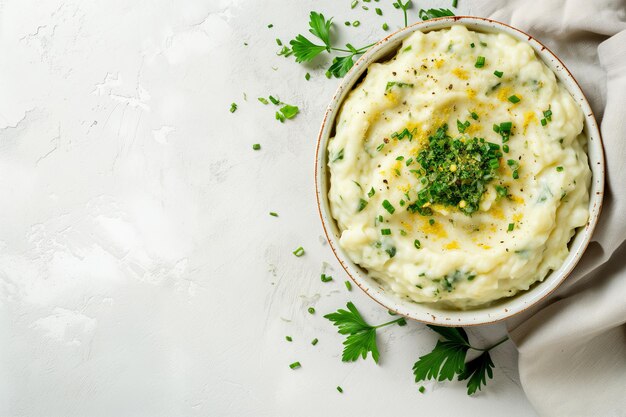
[289,12,374,78]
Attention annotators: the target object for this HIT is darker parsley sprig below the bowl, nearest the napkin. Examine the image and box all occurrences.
[413,325,508,395]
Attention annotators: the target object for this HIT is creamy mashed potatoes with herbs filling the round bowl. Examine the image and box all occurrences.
[328,25,591,309]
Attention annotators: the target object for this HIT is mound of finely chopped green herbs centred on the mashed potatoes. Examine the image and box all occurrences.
[407,124,501,216]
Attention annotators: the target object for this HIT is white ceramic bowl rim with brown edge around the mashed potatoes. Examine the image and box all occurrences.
[315,16,605,326]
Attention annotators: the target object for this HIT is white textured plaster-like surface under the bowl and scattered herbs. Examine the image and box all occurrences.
[0,0,533,417]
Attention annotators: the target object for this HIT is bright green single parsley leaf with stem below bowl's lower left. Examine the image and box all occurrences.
[324,302,406,363]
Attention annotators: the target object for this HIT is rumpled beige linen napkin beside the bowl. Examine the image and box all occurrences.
[471,0,626,417]
